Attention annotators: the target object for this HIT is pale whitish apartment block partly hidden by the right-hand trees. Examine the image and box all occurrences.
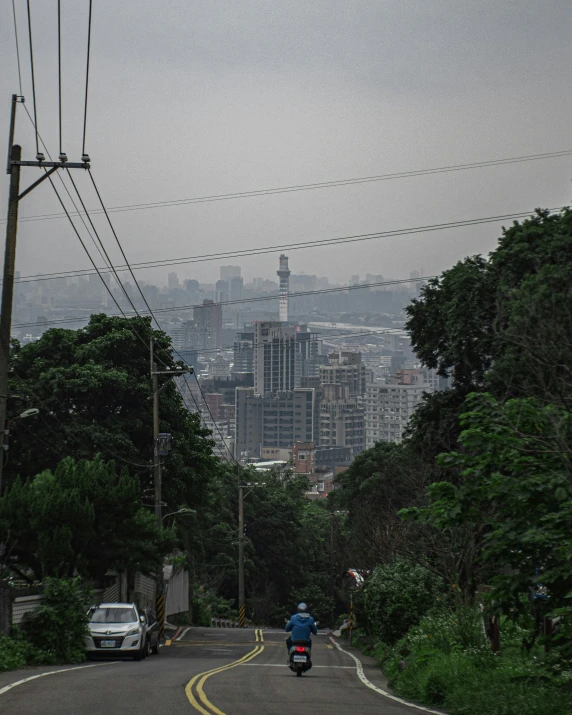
[365,383,432,449]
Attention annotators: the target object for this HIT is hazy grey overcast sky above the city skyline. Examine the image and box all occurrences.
[0,0,572,283]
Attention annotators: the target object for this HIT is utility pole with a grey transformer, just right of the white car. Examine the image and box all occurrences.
[149,335,193,638]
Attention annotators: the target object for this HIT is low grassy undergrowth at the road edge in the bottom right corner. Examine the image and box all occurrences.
[382,609,572,715]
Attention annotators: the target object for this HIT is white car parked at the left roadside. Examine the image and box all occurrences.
[85,603,159,660]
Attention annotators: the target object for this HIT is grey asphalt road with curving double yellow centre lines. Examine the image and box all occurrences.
[0,628,434,715]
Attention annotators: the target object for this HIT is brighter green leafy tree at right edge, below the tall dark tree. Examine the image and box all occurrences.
[406,394,572,612]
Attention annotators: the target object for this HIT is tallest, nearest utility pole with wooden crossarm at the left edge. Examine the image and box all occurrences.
[0,94,90,494]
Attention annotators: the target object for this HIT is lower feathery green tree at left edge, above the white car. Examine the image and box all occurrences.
[0,456,170,580]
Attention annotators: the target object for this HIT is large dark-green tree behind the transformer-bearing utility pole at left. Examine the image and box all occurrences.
[5,315,219,509]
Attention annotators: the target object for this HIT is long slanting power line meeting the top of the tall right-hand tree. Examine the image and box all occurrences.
[10,206,566,283]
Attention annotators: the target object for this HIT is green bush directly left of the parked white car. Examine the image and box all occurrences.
[22,578,91,664]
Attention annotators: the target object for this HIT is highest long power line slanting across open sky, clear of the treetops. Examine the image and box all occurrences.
[7,149,572,227]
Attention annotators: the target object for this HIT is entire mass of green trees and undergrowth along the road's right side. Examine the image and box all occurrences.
[332,210,572,715]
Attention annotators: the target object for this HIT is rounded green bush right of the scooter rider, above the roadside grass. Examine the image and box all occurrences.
[363,559,446,645]
